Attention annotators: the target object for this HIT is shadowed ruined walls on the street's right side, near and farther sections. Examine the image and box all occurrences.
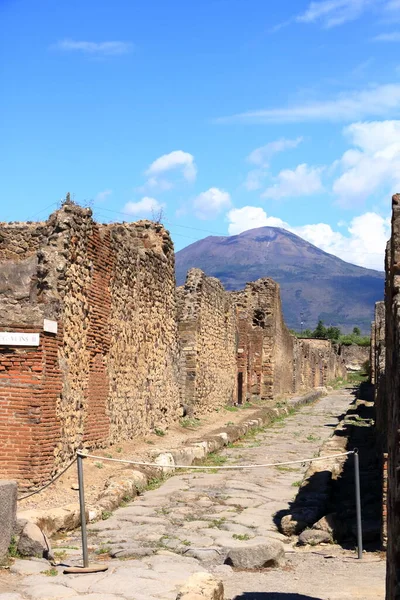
[371,194,400,600]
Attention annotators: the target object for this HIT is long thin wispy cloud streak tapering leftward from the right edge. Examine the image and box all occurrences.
[216,83,400,124]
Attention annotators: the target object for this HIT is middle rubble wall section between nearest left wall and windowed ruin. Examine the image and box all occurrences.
[177,269,237,414]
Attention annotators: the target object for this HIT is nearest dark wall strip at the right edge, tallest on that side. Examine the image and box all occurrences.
[377,194,400,600]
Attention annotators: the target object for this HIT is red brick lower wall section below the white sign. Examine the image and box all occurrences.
[0,327,61,486]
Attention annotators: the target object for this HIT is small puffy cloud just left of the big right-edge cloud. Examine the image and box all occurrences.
[262,163,323,200]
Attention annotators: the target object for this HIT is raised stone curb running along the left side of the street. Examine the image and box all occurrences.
[17,387,327,536]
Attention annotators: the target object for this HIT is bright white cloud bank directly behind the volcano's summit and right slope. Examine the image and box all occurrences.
[227,206,390,271]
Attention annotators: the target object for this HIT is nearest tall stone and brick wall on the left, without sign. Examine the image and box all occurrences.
[0,202,180,484]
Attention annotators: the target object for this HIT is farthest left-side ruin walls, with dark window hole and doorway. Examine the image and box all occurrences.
[232,278,346,400]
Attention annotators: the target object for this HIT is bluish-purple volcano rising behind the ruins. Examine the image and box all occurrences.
[176,226,384,332]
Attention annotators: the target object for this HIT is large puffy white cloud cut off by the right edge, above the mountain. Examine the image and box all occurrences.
[332,121,400,206]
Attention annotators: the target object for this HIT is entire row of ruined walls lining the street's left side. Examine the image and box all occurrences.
[0,201,345,486]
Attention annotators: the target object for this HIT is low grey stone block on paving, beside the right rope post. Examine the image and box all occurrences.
[225,541,285,569]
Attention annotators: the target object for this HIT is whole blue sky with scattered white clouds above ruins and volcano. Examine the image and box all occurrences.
[0,0,400,269]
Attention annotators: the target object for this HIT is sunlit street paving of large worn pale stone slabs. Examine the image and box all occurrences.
[0,390,385,600]
